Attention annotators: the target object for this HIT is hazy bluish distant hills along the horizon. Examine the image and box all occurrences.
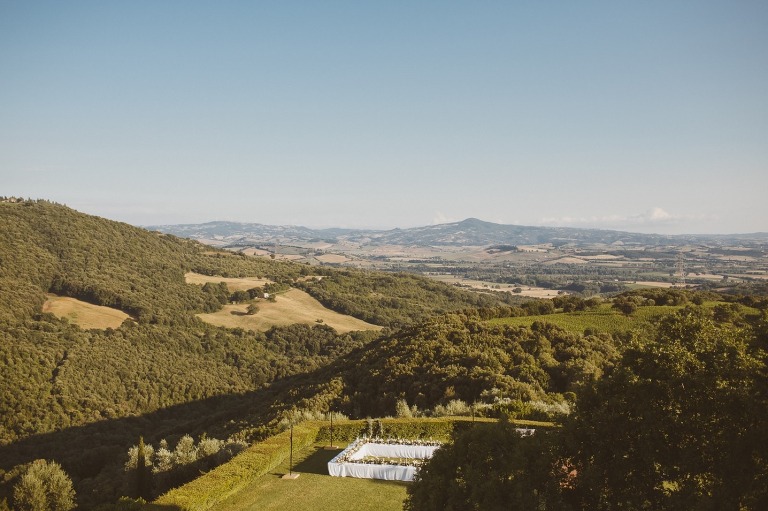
[147,218,768,246]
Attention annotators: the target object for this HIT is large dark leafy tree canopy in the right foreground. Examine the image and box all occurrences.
[407,307,768,511]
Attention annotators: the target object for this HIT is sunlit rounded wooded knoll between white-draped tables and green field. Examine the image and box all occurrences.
[345,314,618,416]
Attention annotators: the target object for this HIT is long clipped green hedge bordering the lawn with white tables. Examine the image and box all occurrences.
[147,417,551,511]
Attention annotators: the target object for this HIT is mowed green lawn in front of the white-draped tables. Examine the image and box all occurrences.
[211,445,409,511]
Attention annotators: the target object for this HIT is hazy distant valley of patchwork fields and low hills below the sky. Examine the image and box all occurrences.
[149,219,768,298]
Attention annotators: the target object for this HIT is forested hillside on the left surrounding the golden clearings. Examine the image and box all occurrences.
[0,201,520,505]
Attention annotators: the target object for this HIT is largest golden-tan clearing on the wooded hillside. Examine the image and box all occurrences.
[197,289,381,333]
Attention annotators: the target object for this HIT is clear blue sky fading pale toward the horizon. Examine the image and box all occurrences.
[0,0,768,233]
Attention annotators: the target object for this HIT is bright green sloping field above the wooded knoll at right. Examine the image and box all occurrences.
[489,304,680,333]
